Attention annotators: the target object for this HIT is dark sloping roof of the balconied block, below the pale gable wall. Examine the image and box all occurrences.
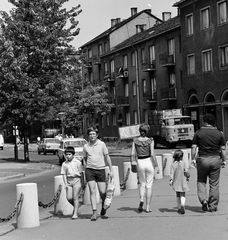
[107,16,180,55]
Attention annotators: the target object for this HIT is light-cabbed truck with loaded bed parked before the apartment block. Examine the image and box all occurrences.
[148,109,194,148]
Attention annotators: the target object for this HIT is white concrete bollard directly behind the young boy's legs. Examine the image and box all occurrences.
[54,175,74,216]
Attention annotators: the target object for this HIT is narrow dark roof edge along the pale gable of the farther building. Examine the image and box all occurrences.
[81,9,162,48]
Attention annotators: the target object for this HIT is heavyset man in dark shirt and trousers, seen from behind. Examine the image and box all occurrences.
[192,113,226,212]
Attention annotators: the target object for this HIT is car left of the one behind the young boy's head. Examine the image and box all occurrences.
[37,138,60,155]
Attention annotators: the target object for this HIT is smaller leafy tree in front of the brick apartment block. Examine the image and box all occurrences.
[78,84,113,124]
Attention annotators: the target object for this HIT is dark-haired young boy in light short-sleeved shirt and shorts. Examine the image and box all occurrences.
[61,146,83,220]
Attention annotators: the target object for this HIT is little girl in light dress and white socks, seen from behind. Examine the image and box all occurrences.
[169,149,190,214]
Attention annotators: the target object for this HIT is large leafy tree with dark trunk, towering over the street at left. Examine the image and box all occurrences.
[0,0,81,161]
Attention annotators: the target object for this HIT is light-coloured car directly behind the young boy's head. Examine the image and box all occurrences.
[58,138,86,166]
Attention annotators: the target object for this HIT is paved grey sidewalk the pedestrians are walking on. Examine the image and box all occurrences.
[0,149,228,240]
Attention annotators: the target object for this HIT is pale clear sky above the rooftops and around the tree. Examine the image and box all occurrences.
[0,0,177,49]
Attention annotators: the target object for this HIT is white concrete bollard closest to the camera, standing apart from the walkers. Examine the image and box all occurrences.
[16,183,40,228]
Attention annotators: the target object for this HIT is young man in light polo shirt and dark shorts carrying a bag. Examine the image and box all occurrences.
[83,126,114,221]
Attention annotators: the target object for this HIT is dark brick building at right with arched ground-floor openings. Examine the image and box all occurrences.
[173,0,228,140]
